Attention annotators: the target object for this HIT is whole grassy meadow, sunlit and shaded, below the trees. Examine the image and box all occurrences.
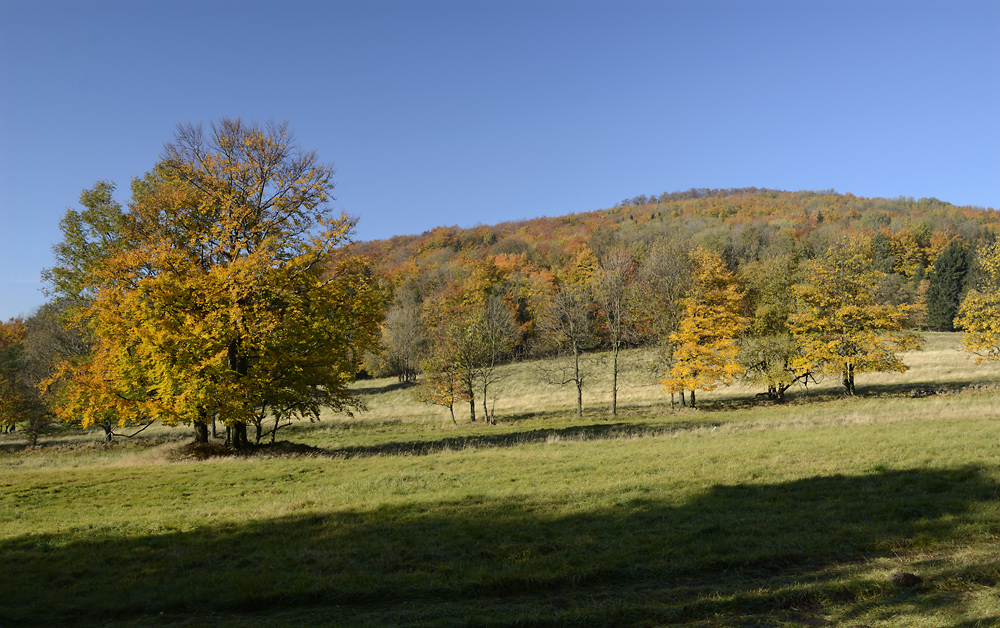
[0,334,1000,628]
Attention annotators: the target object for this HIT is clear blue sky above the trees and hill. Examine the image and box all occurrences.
[0,0,1000,319]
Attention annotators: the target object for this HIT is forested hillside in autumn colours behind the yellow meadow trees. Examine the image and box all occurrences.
[347,188,1000,392]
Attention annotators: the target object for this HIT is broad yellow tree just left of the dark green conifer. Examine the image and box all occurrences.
[790,238,921,395]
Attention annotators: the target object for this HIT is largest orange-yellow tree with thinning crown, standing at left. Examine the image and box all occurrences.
[50,119,381,447]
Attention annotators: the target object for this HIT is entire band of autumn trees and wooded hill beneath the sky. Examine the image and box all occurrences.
[0,119,1000,448]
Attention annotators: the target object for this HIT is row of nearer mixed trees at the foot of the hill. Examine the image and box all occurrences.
[366,234,1000,421]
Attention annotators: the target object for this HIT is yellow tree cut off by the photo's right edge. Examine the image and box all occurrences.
[955,242,1000,362]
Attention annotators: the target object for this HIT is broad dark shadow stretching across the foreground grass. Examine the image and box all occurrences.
[0,467,1000,626]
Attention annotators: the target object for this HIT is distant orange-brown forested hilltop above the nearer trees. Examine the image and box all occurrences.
[354,188,1000,285]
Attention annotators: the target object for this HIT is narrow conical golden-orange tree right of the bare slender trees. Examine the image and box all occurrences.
[660,248,748,406]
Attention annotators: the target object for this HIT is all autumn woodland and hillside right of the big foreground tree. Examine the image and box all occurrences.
[366,188,998,421]
